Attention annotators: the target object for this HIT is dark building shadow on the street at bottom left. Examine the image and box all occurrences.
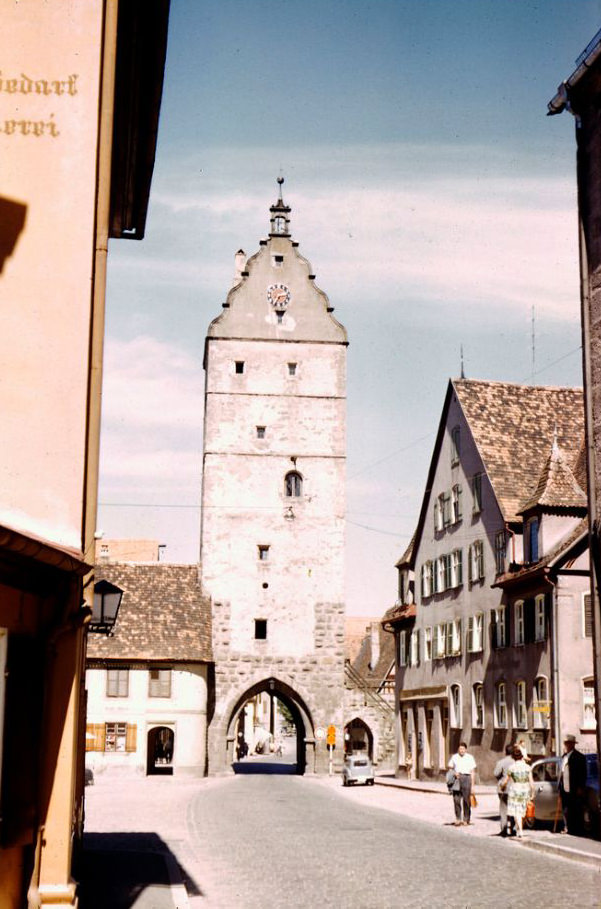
[78,833,203,909]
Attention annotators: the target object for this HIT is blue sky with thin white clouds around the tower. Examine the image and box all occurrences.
[98,0,601,616]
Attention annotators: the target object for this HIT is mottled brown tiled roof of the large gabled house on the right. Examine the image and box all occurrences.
[452,379,584,521]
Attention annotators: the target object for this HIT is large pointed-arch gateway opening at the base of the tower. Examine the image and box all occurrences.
[227,678,314,774]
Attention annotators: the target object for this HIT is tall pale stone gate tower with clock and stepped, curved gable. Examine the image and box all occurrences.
[201,178,348,773]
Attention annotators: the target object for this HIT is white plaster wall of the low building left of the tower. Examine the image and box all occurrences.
[86,664,207,774]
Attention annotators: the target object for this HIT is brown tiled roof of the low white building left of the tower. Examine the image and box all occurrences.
[88,562,213,662]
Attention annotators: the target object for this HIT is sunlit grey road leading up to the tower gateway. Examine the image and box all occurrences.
[84,774,601,909]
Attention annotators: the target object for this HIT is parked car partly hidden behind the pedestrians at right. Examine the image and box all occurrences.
[526,754,600,835]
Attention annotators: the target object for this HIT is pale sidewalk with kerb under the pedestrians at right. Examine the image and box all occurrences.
[376,774,601,869]
